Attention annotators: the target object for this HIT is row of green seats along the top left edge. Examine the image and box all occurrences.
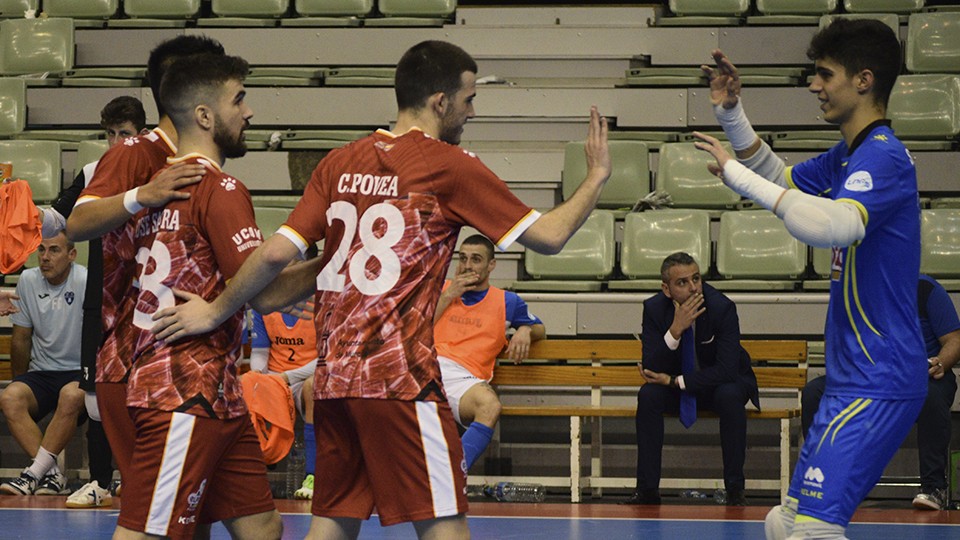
[0,0,457,27]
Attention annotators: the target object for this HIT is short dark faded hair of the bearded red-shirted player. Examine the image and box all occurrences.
[160,54,250,130]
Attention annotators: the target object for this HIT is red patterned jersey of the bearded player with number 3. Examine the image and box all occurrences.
[127,154,263,419]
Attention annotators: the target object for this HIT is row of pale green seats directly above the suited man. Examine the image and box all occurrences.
[512,208,960,291]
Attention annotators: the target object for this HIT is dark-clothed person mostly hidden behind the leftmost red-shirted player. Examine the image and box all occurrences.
[61,96,147,508]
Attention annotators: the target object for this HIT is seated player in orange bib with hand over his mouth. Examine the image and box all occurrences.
[433,234,547,469]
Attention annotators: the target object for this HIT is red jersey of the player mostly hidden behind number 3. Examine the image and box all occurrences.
[77,128,177,382]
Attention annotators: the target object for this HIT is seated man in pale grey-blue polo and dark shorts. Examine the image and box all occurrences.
[0,233,87,495]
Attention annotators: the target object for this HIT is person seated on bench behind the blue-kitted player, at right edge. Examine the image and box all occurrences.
[801,275,960,510]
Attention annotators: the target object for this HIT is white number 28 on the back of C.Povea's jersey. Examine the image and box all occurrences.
[317,201,404,296]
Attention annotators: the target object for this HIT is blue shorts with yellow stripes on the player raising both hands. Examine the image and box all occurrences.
[789,396,924,527]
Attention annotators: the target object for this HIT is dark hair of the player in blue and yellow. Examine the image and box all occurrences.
[807,18,902,109]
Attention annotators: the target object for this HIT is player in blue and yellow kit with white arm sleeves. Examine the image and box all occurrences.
[697,19,927,539]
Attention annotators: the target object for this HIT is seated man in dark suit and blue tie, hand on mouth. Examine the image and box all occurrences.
[624,253,760,506]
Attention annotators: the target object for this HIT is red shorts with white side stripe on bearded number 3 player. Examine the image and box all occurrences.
[117,407,276,538]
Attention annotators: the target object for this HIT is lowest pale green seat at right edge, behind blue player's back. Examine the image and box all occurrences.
[920,208,960,278]
